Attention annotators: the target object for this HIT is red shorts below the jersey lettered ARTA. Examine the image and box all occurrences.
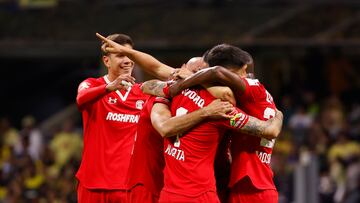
[159,191,220,203]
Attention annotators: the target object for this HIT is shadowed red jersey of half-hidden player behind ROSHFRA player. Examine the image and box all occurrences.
[128,97,169,196]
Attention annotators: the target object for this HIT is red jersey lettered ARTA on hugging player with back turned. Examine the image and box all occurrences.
[160,88,248,198]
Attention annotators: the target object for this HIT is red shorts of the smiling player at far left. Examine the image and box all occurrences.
[77,183,128,203]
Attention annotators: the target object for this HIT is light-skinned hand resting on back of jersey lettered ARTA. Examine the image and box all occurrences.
[203,99,235,119]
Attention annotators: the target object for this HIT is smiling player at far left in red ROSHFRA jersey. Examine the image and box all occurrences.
[76,34,183,203]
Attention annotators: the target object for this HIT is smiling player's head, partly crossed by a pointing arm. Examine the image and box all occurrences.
[101,34,135,76]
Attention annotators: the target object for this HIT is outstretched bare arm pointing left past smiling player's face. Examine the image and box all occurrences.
[96,33,175,80]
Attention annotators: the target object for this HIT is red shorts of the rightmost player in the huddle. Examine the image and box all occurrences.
[228,179,279,203]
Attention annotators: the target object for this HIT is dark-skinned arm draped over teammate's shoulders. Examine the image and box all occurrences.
[169,66,246,96]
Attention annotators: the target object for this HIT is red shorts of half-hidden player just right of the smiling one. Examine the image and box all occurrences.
[129,184,159,203]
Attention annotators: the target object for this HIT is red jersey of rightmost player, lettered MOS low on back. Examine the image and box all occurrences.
[229,78,276,189]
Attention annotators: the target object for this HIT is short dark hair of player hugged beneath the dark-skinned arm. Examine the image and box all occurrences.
[204,44,253,68]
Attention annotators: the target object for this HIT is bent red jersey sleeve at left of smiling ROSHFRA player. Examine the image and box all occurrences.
[76,78,107,110]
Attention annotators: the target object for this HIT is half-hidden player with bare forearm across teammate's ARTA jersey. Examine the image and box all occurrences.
[127,97,233,203]
